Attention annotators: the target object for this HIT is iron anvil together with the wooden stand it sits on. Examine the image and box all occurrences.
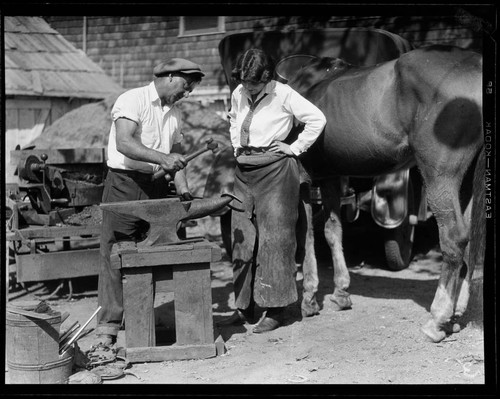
[100,195,239,362]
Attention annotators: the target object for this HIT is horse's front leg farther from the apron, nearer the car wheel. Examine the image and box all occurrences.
[321,180,352,310]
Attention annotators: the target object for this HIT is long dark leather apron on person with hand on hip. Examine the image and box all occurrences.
[231,154,299,309]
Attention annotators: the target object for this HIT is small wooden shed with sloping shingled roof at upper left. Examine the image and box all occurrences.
[2,16,123,183]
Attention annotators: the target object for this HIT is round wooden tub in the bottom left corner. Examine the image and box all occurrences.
[6,312,73,384]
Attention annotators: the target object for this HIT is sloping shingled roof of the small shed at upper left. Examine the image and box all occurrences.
[4,16,123,99]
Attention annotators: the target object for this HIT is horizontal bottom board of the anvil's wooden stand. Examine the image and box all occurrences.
[126,344,216,363]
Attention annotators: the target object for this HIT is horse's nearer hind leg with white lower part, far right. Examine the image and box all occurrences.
[422,182,468,342]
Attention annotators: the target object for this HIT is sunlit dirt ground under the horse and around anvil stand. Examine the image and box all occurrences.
[5,220,485,393]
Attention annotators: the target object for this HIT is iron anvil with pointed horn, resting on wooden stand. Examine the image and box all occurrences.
[100,194,241,248]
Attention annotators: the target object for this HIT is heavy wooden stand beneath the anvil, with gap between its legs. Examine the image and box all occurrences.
[111,240,222,362]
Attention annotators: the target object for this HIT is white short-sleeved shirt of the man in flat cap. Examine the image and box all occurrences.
[107,82,183,173]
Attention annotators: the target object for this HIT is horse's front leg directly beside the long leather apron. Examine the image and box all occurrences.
[301,202,319,317]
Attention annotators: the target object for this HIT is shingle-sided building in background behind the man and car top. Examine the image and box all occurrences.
[45,12,484,110]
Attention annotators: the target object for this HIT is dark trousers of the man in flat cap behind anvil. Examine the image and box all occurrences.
[96,170,165,335]
